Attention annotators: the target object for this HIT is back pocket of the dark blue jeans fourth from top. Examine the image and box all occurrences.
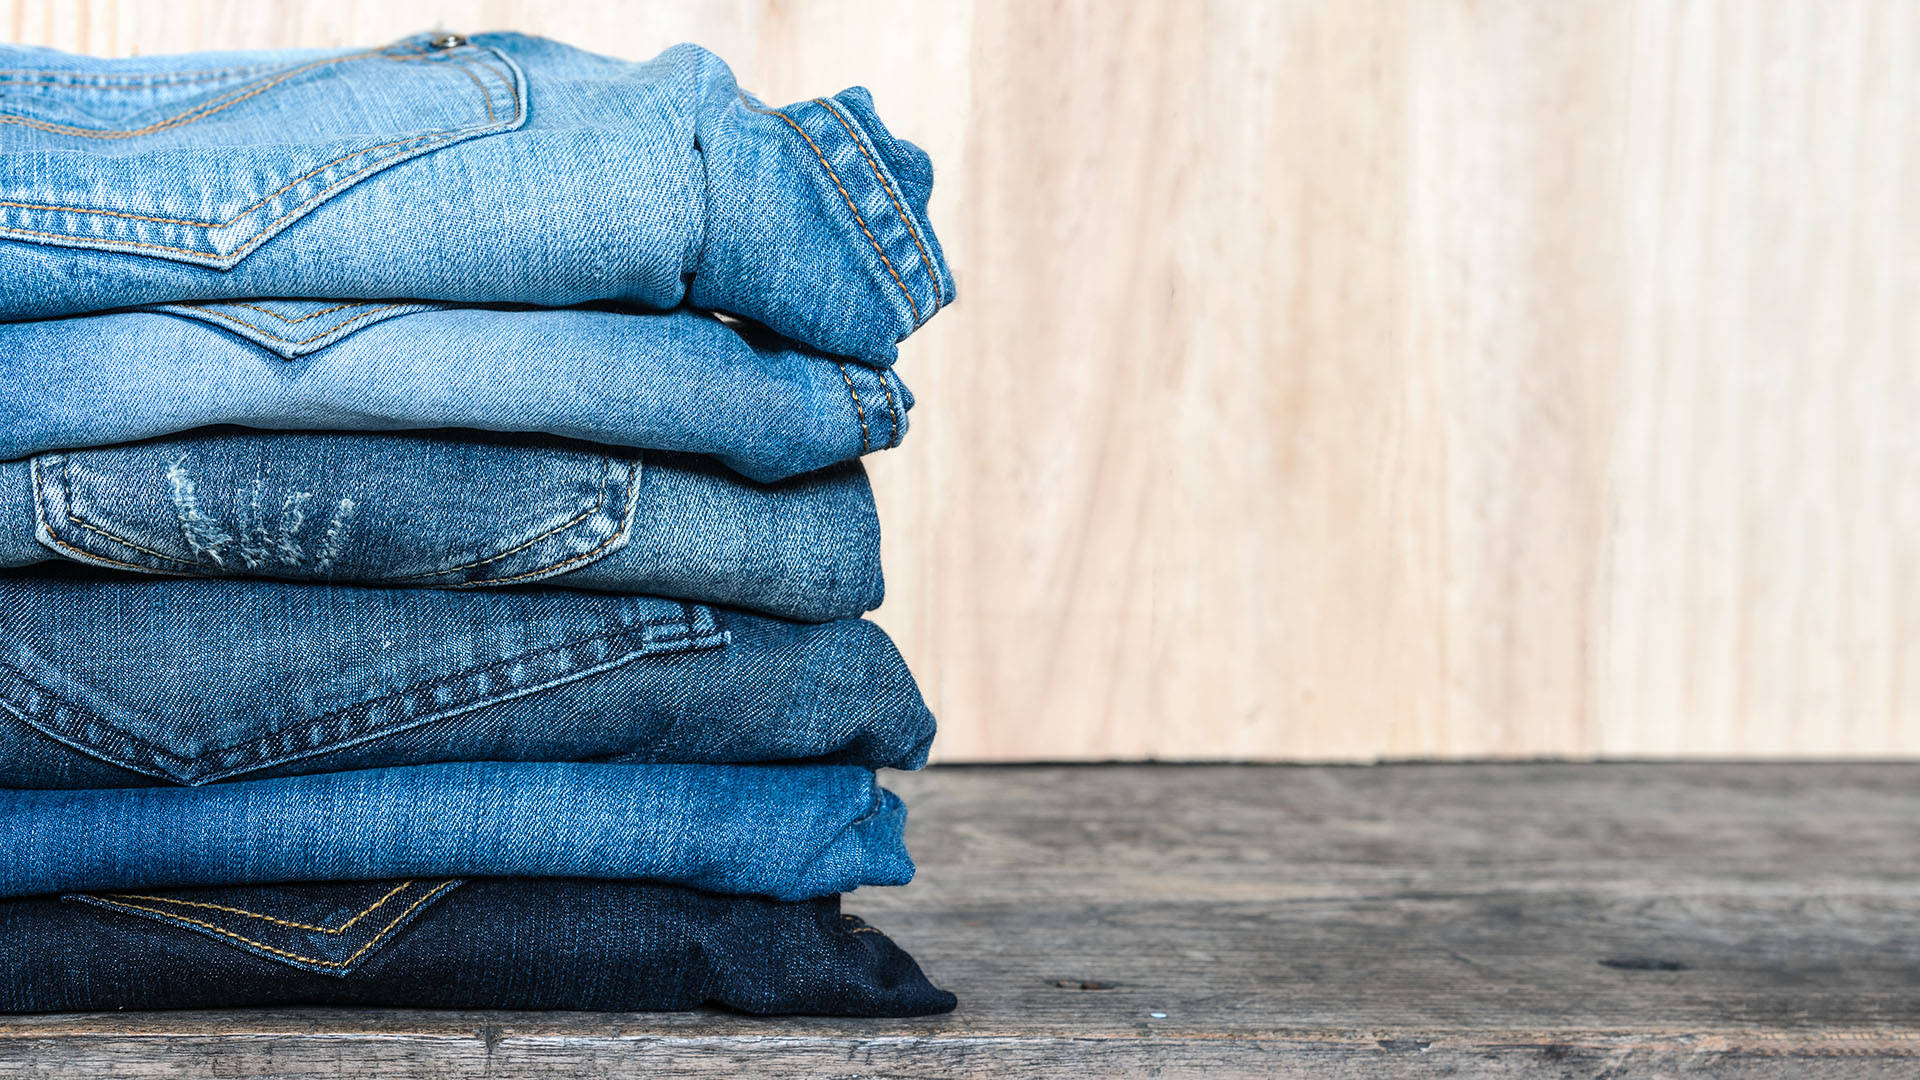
[0,571,730,784]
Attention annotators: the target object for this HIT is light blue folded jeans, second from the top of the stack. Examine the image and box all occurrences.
[0,303,912,480]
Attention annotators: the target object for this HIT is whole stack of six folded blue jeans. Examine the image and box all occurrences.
[0,35,954,1017]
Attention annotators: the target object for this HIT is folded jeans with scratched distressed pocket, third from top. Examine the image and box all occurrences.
[0,429,881,621]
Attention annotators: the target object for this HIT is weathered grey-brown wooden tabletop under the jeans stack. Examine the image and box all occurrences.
[0,765,1920,1080]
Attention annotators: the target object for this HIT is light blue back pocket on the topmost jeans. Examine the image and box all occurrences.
[0,37,526,269]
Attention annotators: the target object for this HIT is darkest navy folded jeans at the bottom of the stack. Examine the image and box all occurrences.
[0,878,954,1017]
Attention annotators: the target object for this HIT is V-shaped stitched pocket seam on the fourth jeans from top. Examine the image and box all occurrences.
[0,603,730,786]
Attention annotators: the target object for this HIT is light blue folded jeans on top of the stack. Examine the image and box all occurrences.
[0,35,952,361]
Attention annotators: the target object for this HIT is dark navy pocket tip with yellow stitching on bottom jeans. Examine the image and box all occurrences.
[61,878,465,978]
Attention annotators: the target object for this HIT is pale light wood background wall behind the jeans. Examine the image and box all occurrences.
[0,0,1920,761]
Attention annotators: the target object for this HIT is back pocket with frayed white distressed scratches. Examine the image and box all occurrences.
[31,430,641,586]
